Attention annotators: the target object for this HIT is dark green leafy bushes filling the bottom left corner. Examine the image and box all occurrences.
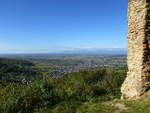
[0,80,56,113]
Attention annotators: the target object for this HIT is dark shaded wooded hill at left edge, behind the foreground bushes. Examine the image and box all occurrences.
[0,58,41,84]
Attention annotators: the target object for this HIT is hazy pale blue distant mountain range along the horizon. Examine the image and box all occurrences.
[0,48,127,56]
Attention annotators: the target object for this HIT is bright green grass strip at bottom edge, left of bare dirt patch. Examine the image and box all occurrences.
[41,102,118,113]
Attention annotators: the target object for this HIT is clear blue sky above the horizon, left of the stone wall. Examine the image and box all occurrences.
[0,0,127,53]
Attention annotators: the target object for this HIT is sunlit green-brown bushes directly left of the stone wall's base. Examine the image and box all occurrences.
[56,69,126,101]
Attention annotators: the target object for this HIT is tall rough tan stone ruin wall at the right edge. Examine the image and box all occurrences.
[121,0,150,99]
